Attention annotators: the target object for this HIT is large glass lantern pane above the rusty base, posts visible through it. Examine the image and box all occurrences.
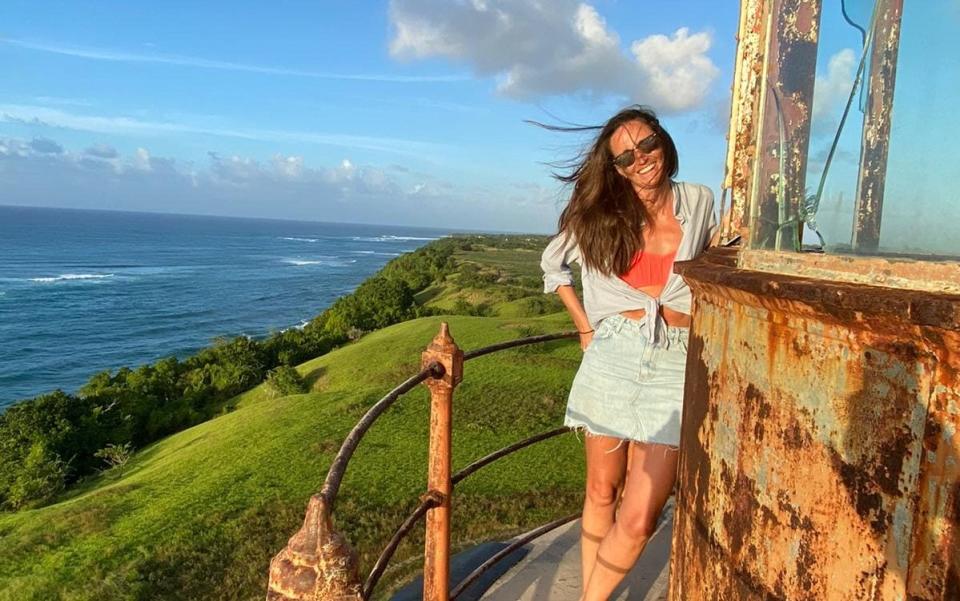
[750,0,960,258]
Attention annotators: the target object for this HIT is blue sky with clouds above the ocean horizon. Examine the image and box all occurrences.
[0,0,960,238]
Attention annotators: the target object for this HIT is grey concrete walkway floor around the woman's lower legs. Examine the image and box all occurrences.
[482,499,673,601]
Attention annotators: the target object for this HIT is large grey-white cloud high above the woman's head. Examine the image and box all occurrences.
[390,0,719,112]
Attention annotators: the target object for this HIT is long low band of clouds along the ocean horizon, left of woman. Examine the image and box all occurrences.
[0,138,553,231]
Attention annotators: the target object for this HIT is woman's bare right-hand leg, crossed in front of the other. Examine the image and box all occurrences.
[583,443,680,601]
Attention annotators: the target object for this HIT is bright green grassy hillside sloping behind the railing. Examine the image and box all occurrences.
[0,237,582,600]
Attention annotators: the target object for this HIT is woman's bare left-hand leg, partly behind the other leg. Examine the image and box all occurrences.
[580,434,630,588]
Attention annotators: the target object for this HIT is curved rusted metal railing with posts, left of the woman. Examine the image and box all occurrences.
[267,323,579,601]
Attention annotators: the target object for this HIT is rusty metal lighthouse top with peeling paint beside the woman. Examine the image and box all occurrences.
[671,0,960,601]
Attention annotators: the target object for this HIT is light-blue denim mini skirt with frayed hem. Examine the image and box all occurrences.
[563,315,690,447]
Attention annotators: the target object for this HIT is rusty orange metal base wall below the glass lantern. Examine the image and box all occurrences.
[670,251,960,601]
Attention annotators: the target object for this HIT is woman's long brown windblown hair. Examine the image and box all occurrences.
[547,105,679,275]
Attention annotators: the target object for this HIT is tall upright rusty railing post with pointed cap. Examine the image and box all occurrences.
[422,323,463,601]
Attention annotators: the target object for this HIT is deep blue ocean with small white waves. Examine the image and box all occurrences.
[0,206,449,410]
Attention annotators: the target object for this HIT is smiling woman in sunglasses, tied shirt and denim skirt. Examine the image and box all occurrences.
[541,106,716,601]
